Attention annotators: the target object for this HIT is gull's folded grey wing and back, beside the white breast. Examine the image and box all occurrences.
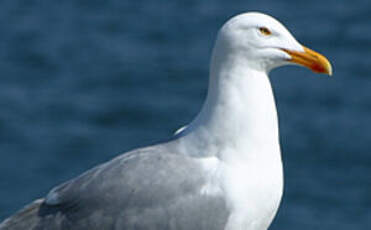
[0,146,228,230]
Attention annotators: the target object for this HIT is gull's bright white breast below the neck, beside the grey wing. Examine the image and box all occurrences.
[223,147,283,230]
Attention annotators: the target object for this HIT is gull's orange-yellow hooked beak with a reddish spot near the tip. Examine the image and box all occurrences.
[283,46,332,76]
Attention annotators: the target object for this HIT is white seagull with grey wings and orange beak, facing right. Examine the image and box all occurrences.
[0,12,332,230]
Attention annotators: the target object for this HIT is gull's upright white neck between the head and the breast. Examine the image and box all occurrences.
[173,40,279,160]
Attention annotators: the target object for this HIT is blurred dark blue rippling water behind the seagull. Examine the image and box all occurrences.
[0,0,371,230]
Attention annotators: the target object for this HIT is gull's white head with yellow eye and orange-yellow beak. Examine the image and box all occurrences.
[217,13,332,75]
